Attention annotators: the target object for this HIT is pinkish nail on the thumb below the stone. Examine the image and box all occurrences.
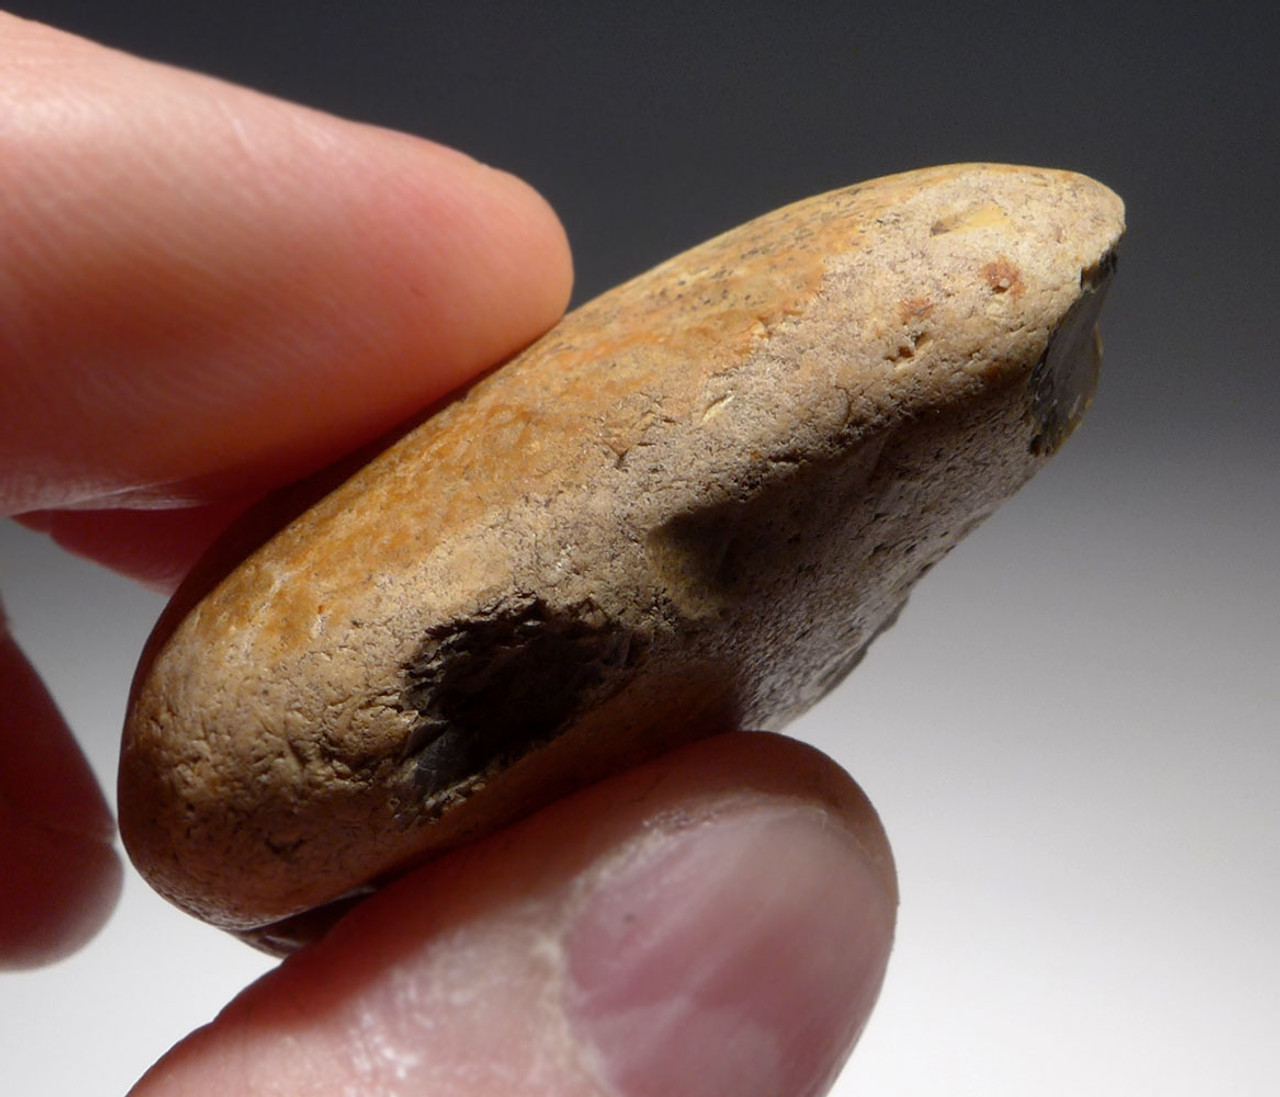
[564,804,893,1097]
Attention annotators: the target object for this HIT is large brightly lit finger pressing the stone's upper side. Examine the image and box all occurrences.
[0,15,571,513]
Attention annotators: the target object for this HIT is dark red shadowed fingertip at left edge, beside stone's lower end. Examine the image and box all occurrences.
[0,607,122,969]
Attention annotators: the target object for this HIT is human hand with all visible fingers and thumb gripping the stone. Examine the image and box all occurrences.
[0,14,895,1097]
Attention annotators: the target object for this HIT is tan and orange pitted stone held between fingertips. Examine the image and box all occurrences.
[120,165,1123,941]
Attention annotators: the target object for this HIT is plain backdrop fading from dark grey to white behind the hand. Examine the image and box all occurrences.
[0,0,1280,1097]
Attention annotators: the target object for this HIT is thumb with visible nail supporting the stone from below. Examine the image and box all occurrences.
[127,735,896,1097]
